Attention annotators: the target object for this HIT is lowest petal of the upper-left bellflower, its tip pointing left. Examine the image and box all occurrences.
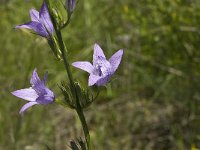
[15,21,48,37]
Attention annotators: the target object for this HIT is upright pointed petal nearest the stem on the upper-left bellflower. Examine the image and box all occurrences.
[39,2,53,34]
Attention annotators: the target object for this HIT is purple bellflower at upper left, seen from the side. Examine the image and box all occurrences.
[15,2,53,39]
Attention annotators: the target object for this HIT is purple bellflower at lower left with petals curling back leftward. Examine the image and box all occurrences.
[12,69,55,114]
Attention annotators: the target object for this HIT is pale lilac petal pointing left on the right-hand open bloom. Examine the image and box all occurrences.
[72,61,93,73]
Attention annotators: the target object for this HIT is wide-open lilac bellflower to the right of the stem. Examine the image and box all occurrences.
[72,44,123,86]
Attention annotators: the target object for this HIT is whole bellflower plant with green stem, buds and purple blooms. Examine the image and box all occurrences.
[12,0,123,150]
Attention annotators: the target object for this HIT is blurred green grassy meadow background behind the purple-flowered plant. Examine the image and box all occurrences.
[0,0,200,150]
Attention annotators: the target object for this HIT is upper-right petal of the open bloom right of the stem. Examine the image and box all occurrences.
[109,49,123,73]
